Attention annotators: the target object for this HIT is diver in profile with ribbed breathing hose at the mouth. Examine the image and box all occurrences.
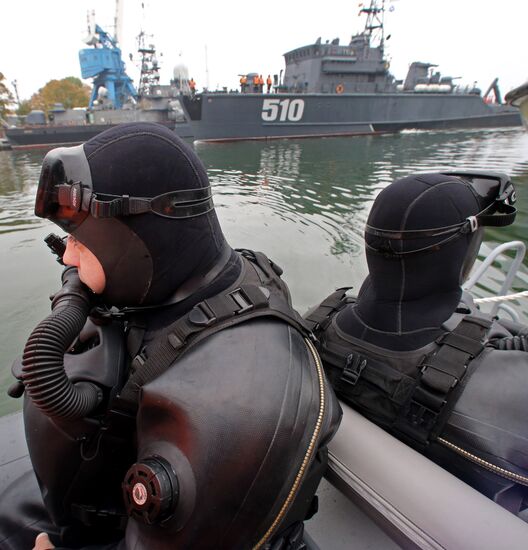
[0,123,340,550]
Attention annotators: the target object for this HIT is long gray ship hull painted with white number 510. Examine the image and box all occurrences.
[182,92,522,141]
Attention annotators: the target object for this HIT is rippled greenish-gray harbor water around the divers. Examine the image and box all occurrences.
[0,129,528,414]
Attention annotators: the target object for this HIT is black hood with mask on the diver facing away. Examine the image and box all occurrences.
[338,173,515,350]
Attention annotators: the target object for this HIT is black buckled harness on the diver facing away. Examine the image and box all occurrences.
[306,288,491,450]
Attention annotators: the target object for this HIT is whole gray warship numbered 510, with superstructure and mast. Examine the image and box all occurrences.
[182,0,521,141]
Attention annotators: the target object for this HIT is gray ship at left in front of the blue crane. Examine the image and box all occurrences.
[5,15,192,149]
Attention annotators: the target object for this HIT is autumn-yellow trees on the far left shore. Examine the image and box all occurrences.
[0,72,90,117]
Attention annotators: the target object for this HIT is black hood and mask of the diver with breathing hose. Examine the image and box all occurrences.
[35,123,226,306]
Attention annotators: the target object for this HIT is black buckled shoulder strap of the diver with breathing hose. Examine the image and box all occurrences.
[118,251,311,413]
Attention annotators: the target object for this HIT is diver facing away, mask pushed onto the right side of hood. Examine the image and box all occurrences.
[308,173,528,513]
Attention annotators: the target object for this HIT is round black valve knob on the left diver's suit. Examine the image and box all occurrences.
[122,456,179,525]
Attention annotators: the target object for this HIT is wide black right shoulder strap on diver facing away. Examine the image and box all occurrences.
[393,315,491,448]
